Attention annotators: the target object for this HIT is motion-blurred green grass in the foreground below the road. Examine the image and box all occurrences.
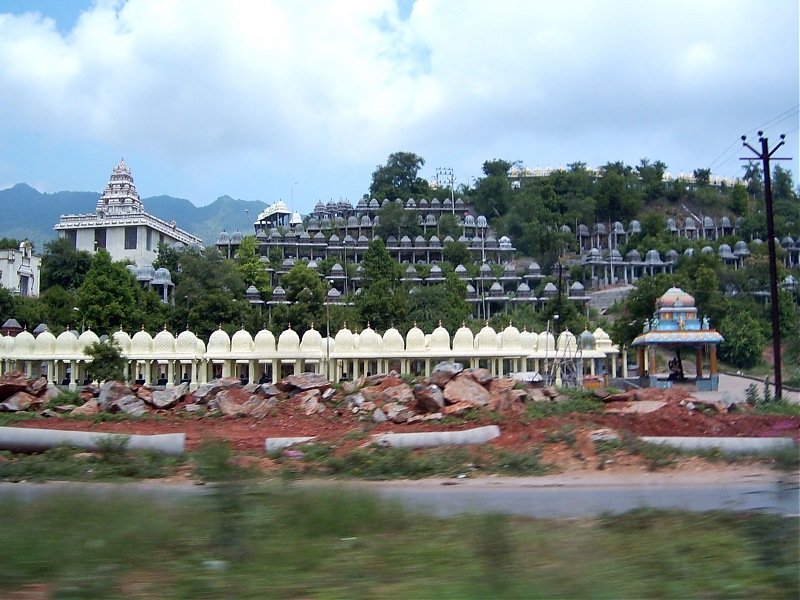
[0,485,800,599]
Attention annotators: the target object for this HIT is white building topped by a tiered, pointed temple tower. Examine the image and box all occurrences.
[54,160,202,267]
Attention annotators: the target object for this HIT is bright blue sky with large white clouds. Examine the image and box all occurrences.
[0,0,800,213]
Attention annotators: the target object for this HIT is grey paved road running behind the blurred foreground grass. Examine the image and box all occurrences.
[0,472,800,518]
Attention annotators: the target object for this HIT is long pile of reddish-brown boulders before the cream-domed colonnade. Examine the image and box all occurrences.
[0,362,566,423]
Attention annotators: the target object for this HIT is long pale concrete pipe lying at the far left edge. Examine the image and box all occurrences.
[0,427,186,455]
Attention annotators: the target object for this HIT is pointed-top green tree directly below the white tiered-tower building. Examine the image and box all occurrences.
[77,248,137,332]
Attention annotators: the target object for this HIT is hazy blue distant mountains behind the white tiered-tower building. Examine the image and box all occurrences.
[0,183,267,254]
